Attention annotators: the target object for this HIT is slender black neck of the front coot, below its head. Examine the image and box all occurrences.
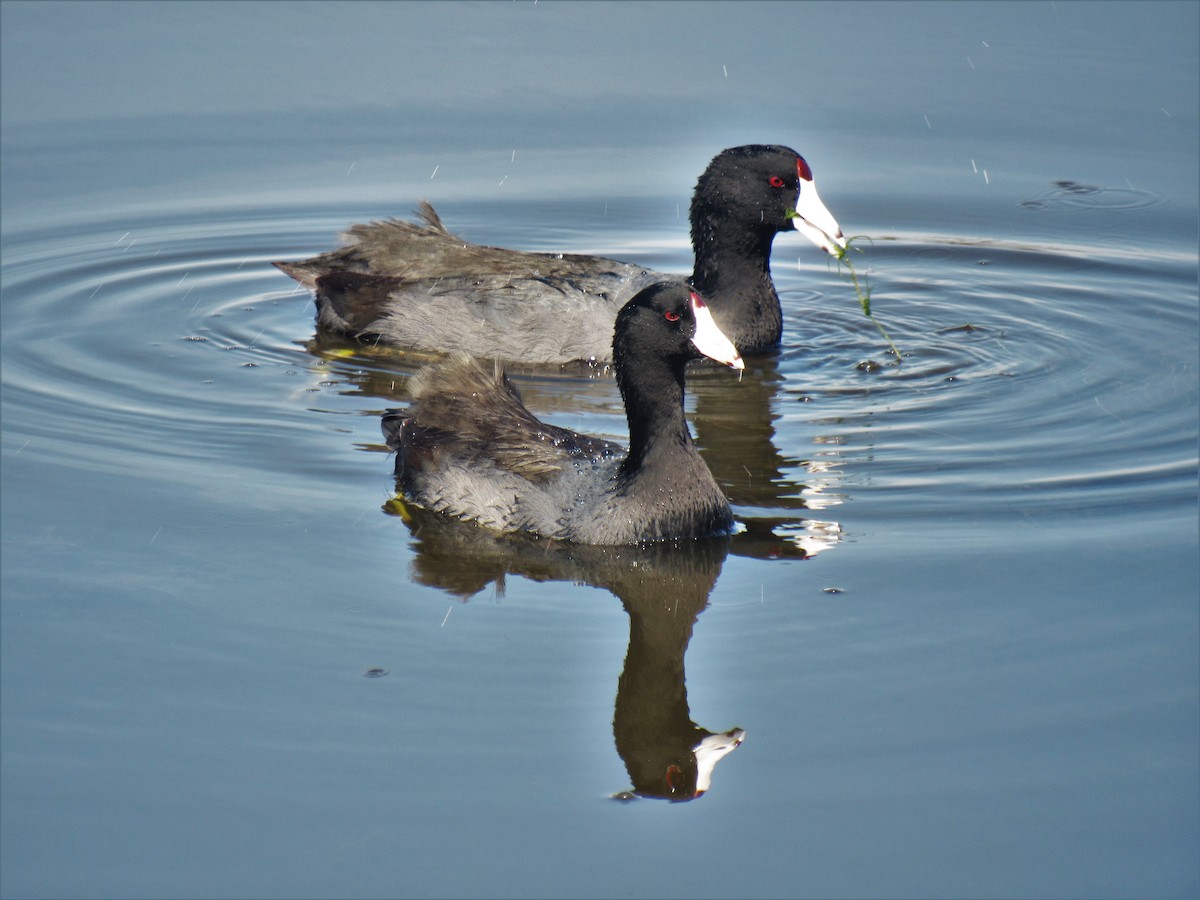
[617,356,696,481]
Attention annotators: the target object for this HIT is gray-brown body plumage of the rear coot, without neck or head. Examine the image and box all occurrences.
[277,202,667,364]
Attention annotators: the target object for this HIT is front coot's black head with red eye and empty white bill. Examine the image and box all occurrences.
[612,282,745,368]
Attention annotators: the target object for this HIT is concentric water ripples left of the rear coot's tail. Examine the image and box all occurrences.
[4,207,374,496]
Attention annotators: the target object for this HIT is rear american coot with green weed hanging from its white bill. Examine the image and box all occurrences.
[275,144,846,364]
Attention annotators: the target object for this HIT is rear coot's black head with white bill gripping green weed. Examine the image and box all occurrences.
[691,144,846,256]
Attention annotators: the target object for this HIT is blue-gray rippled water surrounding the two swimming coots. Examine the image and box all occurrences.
[0,0,1200,898]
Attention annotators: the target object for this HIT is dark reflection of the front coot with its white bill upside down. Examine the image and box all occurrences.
[389,500,744,800]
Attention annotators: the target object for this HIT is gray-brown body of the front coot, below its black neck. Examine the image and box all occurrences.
[384,354,733,545]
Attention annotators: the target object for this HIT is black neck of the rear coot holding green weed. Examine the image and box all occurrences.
[691,202,784,353]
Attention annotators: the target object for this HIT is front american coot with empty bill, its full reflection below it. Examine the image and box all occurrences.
[383,282,743,545]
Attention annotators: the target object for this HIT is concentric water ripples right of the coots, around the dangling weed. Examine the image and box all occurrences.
[763,235,1198,528]
